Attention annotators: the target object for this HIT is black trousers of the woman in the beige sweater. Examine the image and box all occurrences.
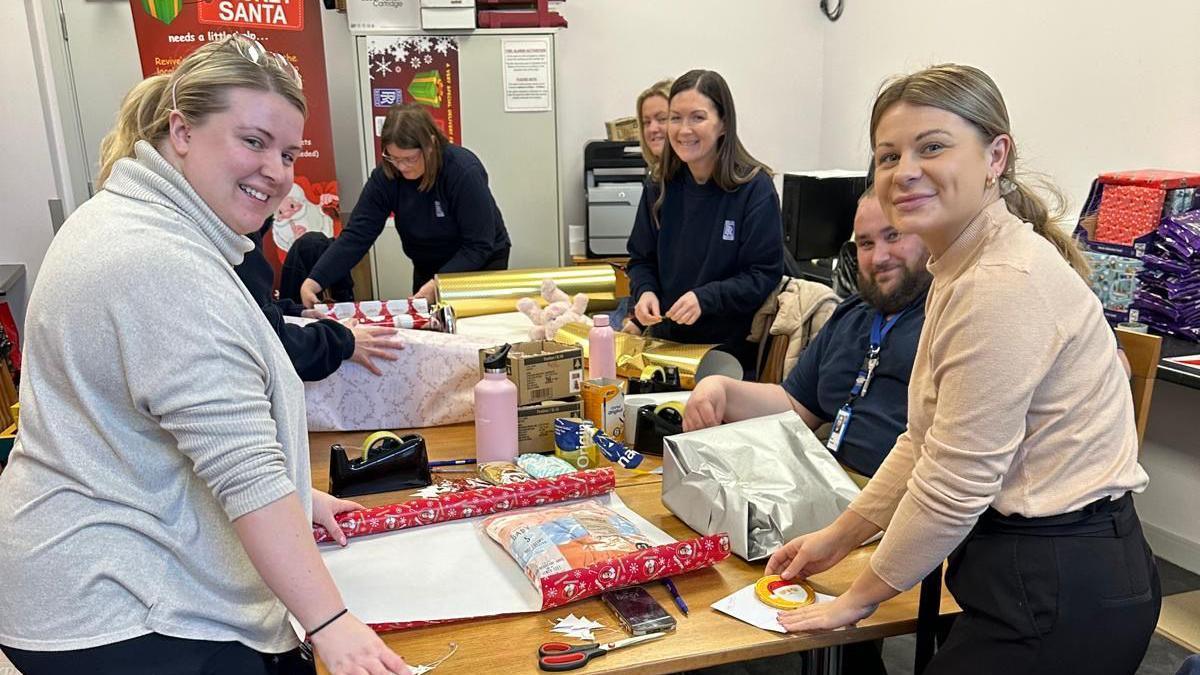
[925,487,1163,675]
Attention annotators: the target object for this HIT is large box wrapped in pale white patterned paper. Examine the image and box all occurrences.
[305,330,496,431]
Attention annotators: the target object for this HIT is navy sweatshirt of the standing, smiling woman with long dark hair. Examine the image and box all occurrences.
[628,167,784,345]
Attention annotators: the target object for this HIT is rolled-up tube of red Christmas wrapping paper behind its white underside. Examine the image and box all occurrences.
[312,467,617,544]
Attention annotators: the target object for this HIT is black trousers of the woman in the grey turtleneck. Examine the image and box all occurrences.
[0,633,316,675]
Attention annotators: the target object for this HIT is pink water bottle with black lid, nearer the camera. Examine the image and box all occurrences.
[475,345,517,464]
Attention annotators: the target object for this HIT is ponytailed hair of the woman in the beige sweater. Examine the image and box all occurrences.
[871,64,1090,280]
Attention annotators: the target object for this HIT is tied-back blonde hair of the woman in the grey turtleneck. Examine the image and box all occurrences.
[96,34,308,187]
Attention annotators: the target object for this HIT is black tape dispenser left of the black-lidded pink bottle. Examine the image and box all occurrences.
[329,431,433,497]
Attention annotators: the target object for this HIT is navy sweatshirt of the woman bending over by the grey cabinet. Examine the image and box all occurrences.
[310,144,511,287]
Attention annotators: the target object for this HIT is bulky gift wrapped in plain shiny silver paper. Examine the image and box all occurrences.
[662,412,859,561]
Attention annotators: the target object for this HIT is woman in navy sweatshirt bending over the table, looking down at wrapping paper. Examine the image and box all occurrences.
[300,103,511,307]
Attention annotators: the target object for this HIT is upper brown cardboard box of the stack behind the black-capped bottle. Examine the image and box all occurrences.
[479,340,583,406]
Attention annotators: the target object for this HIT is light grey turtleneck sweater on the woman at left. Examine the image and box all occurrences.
[0,142,311,652]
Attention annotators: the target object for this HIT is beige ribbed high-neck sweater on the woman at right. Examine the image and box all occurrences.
[850,199,1147,591]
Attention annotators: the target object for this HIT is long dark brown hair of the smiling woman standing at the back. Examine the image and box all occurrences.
[653,70,774,225]
